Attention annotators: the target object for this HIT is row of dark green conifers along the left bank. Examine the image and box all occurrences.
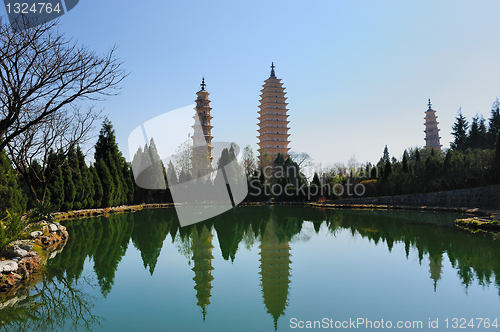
[0,119,175,214]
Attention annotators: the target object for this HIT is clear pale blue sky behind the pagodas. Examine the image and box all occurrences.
[0,0,500,165]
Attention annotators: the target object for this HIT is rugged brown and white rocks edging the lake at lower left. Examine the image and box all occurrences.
[0,221,69,296]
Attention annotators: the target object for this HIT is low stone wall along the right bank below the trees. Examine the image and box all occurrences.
[334,185,500,210]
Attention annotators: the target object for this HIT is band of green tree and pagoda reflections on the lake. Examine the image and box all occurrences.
[0,207,500,331]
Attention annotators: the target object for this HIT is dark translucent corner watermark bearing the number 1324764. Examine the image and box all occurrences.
[3,0,79,30]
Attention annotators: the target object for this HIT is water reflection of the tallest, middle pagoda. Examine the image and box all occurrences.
[260,217,291,330]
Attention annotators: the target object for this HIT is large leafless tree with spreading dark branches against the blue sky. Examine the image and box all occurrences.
[0,21,126,150]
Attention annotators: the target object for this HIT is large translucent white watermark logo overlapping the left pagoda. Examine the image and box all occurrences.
[128,105,248,226]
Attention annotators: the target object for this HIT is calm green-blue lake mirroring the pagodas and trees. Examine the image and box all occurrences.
[0,206,500,331]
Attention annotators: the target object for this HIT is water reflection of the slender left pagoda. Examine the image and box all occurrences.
[191,225,214,321]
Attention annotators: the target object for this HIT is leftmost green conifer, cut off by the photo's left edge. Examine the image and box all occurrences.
[0,150,26,218]
